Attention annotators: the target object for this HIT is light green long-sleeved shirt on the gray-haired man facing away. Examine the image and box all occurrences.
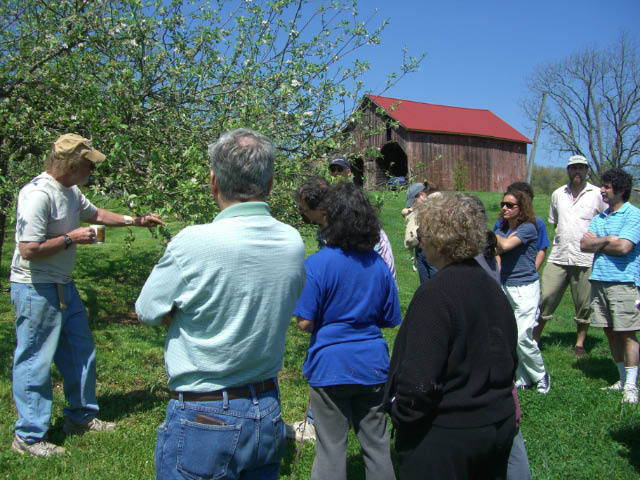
[136,202,305,391]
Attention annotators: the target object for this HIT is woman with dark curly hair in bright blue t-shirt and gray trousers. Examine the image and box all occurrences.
[294,182,401,480]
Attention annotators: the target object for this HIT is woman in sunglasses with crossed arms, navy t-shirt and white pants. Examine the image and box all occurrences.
[496,190,551,394]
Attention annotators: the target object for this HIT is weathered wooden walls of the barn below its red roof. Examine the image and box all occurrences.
[345,100,527,192]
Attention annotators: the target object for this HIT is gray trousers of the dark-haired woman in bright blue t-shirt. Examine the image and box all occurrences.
[311,385,396,480]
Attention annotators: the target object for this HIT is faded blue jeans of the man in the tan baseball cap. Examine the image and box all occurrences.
[11,282,98,443]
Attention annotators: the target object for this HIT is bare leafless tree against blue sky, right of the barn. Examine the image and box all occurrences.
[523,33,640,177]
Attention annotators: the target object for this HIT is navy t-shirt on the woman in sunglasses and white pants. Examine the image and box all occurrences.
[496,222,539,286]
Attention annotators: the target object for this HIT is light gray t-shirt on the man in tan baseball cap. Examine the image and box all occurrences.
[10,172,97,283]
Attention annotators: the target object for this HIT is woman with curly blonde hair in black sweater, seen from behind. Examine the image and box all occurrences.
[386,195,517,479]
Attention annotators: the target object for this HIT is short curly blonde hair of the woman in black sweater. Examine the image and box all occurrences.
[416,194,487,262]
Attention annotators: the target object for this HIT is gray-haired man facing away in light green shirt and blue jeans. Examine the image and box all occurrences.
[136,129,305,479]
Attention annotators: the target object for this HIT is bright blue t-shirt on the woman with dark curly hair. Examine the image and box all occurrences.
[294,246,401,387]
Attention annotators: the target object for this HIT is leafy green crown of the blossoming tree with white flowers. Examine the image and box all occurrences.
[0,0,422,272]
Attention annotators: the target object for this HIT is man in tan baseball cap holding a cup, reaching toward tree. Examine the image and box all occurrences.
[10,133,164,457]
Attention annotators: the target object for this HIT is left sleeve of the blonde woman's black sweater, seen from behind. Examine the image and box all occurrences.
[388,289,451,426]
